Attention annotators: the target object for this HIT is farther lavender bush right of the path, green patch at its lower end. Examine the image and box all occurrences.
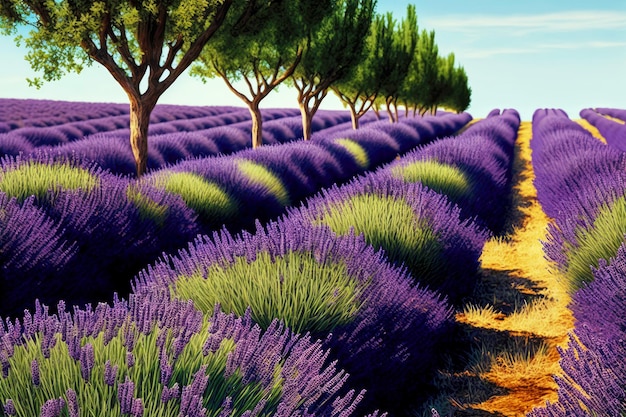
[531,112,626,292]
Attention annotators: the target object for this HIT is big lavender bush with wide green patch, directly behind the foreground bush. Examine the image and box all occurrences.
[133,217,452,413]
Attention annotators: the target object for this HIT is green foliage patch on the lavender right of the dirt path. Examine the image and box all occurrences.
[563,196,626,293]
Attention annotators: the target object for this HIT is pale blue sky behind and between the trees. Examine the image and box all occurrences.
[0,0,626,120]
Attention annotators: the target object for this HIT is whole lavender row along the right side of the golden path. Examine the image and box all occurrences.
[529,109,626,417]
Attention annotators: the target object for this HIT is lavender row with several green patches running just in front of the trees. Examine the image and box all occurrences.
[0,110,471,316]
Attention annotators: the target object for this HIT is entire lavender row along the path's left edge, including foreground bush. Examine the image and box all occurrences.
[0,112,519,417]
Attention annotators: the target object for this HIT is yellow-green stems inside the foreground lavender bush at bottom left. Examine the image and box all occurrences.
[0,318,282,417]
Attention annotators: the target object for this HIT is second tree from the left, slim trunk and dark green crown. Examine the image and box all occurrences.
[191,0,337,147]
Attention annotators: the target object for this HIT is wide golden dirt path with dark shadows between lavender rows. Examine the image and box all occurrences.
[422,122,573,417]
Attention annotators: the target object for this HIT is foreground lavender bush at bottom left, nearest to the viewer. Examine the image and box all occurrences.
[0,293,362,417]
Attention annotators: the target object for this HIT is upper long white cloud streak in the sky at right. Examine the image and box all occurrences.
[424,10,626,35]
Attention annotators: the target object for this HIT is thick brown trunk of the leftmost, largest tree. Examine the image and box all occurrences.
[130,98,156,178]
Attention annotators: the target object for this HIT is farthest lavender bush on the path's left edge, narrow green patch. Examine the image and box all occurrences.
[386,110,520,233]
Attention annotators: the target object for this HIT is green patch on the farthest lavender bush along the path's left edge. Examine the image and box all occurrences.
[391,159,471,201]
